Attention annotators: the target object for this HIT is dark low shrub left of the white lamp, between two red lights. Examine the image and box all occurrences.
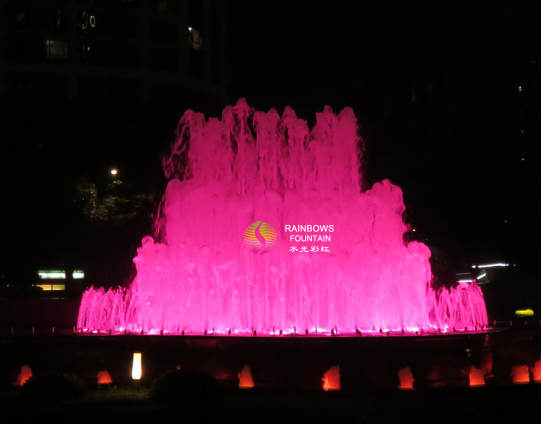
[22,373,86,402]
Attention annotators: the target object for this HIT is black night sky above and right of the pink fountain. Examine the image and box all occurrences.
[229,1,541,284]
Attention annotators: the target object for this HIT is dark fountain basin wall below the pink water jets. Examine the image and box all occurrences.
[0,328,541,391]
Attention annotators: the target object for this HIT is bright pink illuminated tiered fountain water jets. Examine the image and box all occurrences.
[77,100,487,334]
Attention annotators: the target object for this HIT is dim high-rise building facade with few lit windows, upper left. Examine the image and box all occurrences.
[0,0,227,103]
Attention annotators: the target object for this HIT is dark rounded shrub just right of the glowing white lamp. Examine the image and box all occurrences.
[149,370,221,406]
